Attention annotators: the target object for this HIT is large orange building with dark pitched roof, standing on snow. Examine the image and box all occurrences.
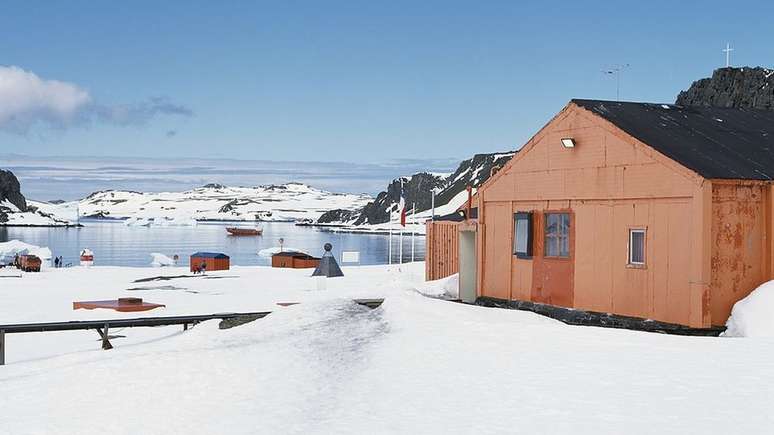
[436,100,774,327]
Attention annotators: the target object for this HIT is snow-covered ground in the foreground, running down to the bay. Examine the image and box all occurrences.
[0,263,774,434]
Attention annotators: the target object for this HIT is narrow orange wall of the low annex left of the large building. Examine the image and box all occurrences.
[425,221,460,281]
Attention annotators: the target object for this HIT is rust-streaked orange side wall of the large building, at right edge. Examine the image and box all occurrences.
[710,181,769,325]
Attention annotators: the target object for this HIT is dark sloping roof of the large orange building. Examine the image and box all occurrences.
[572,100,774,180]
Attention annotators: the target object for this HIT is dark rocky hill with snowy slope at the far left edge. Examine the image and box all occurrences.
[0,169,71,226]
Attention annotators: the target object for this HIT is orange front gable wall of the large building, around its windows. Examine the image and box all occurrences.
[479,105,709,326]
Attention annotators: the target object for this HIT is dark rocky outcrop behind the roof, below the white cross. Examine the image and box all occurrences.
[675,67,774,110]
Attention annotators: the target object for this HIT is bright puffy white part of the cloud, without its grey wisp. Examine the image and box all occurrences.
[0,66,91,132]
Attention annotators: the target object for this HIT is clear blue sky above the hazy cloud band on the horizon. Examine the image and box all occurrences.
[0,1,774,169]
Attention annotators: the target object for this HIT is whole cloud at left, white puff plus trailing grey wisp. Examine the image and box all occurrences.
[0,66,193,133]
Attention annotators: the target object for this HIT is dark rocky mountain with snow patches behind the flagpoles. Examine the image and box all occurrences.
[317,151,515,226]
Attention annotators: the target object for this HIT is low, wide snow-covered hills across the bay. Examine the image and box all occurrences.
[80,183,372,223]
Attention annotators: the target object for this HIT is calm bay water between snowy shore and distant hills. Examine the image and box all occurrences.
[0,219,425,267]
